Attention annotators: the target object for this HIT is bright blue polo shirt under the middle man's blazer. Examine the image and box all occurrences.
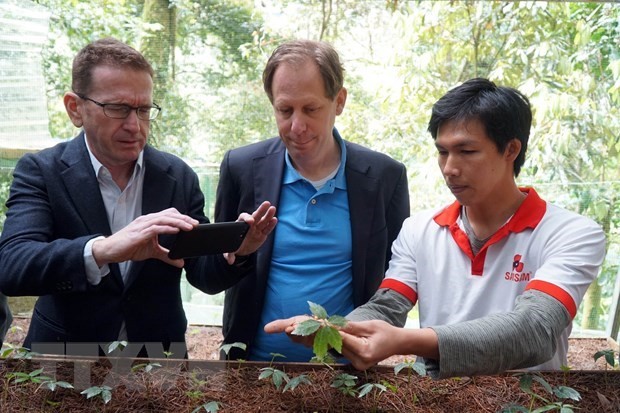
[250,130,353,362]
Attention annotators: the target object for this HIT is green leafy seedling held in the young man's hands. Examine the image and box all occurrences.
[293,301,347,364]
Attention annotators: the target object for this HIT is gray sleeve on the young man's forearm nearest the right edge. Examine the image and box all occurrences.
[426,290,571,378]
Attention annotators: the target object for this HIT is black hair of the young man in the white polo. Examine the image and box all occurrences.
[428,78,532,176]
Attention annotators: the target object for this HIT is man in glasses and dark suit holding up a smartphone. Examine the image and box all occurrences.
[0,39,275,357]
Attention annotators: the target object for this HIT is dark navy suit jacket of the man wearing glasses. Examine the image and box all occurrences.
[0,134,247,357]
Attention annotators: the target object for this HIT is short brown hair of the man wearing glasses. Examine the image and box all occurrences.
[71,37,153,94]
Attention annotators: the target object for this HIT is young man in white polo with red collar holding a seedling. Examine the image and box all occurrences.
[265,79,605,378]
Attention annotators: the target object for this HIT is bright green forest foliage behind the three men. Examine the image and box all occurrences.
[0,0,620,334]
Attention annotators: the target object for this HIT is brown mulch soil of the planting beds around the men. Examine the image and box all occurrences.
[0,318,620,413]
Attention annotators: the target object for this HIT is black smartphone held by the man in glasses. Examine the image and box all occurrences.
[168,221,250,259]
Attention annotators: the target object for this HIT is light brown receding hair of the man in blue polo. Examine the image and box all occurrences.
[263,40,344,103]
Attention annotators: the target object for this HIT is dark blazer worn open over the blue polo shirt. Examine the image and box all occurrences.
[207,138,409,358]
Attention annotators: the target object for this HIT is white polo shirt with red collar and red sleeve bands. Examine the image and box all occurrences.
[380,189,605,369]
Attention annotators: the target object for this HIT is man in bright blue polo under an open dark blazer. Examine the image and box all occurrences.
[207,40,409,361]
